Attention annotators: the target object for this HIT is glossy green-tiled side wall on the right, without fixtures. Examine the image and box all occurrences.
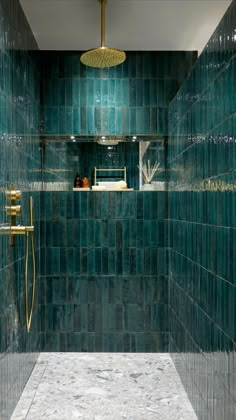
[168,1,236,420]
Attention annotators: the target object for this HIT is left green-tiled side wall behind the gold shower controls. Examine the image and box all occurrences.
[0,0,41,420]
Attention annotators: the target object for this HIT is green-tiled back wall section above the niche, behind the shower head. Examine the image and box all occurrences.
[41,51,196,135]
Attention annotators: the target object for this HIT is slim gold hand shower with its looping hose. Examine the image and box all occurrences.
[25,196,36,332]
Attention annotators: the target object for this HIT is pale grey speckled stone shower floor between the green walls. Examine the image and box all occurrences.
[11,353,196,420]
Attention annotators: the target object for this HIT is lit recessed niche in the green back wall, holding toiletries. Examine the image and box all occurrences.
[41,138,165,191]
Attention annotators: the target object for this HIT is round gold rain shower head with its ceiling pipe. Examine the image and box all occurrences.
[80,0,126,68]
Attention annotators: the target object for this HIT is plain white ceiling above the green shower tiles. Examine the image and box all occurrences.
[20,0,231,51]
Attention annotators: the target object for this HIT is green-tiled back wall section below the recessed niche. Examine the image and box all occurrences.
[40,192,169,352]
